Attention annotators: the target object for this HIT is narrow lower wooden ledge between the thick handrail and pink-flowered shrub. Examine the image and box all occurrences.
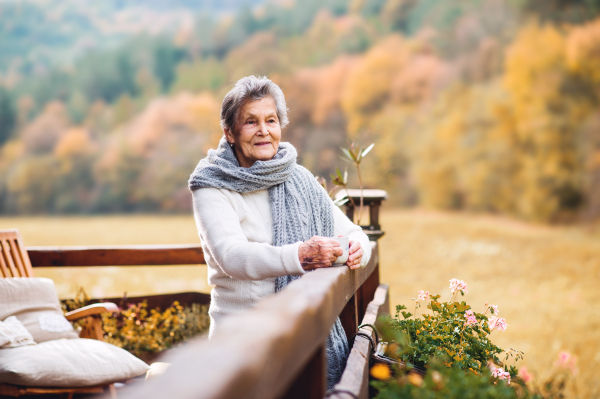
[329,284,389,399]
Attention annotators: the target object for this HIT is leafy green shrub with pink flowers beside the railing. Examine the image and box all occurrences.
[371,279,578,399]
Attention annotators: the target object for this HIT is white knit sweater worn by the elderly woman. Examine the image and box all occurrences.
[193,188,371,336]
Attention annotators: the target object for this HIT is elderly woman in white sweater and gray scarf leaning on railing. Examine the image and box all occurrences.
[189,76,370,387]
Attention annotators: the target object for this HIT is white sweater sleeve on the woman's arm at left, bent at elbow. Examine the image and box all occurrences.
[193,188,304,280]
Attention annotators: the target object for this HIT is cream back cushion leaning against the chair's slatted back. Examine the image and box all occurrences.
[0,277,79,343]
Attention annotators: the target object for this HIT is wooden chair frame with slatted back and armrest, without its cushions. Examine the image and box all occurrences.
[0,229,119,399]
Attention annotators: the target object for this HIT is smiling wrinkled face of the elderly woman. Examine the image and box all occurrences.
[225,97,281,168]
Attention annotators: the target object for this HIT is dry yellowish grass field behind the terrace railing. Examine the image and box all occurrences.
[0,210,600,398]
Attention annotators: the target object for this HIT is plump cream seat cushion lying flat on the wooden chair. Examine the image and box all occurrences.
[0,338,148,387]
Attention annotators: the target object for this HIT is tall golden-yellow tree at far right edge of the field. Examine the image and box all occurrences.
[504,24,593,221]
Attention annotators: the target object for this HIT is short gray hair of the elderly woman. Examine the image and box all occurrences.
[221,75,289,132]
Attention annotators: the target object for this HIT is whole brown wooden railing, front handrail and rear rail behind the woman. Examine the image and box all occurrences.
[27,242,389,399]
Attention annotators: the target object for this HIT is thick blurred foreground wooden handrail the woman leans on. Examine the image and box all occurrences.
[116,243,378,399]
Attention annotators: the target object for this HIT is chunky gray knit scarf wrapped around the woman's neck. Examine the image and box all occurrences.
[188,137,349,389]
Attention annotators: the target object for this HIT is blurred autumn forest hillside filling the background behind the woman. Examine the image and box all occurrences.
[0,0,600,222]
